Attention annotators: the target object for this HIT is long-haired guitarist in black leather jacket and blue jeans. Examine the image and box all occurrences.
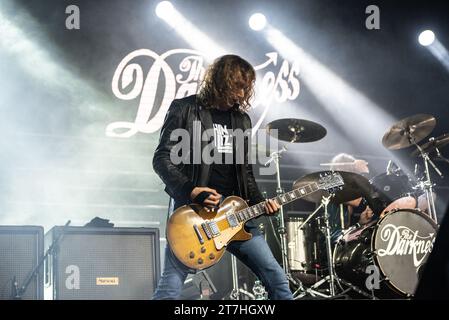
[153,55,293,300]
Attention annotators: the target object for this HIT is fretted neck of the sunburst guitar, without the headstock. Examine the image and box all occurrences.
[234,183,319,222]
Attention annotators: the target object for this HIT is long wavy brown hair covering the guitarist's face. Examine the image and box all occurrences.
[197,55,256,112]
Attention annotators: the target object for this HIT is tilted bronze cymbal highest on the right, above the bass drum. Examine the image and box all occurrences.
[382,114,436,150]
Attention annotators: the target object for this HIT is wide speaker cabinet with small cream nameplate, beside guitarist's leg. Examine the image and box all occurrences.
[45,227,160,300]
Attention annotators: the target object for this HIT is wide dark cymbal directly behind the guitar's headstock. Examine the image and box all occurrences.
[293,171,372,203]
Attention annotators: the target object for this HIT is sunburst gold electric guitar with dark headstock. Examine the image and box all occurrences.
[167,172,344,270]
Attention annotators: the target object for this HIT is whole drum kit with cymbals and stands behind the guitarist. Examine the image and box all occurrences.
[266,114,449,299]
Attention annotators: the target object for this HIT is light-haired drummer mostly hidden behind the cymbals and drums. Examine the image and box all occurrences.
[328,153,375,242]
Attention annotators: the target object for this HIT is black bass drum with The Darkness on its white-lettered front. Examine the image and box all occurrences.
[333,209,437,298]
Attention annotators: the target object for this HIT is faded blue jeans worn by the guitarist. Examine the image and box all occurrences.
[153,235,293,300]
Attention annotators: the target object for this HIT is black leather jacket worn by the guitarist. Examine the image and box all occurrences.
[153,95,264,210]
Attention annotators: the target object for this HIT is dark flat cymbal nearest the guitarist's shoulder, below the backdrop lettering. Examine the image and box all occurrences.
[266,118,327,142]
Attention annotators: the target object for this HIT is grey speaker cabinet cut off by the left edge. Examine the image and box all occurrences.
[0,226,44,300]
